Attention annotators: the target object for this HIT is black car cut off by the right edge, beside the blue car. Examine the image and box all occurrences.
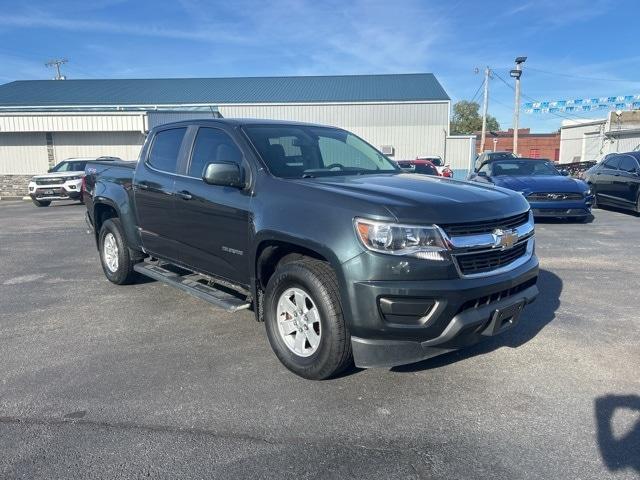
[585,152,640,213]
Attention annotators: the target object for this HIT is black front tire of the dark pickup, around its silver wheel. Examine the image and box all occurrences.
[264,257,353,380]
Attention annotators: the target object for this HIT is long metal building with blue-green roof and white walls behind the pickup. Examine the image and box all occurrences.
[0,73,474,196]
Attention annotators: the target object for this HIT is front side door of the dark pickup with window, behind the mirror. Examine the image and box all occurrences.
[175,126,251,285]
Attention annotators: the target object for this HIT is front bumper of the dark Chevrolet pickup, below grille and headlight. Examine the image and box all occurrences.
[342,255,538,368]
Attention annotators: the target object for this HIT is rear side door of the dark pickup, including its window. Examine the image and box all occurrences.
[134,127,187,260]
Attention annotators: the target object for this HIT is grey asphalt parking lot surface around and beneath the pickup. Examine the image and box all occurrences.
[0,202,640,479]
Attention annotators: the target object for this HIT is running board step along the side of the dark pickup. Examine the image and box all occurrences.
[133,262,251,312]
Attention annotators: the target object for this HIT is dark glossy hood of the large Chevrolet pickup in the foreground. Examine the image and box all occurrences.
[297,173,529,224]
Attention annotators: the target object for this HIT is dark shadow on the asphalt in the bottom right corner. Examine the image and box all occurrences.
[594,394,640,473]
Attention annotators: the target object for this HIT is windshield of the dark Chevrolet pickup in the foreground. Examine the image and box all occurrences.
[244,125,400,178]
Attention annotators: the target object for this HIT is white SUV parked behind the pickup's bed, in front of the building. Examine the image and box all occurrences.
[29,157,120,207]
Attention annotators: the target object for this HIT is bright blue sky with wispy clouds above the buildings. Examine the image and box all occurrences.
[0,0,640,131]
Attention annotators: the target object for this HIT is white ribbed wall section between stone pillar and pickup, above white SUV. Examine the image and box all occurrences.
[53,132,144,163]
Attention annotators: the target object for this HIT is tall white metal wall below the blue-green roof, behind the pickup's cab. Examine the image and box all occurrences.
[218,102,449,160]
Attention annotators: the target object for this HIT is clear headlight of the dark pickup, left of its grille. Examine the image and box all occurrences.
[354,218,448,260]
